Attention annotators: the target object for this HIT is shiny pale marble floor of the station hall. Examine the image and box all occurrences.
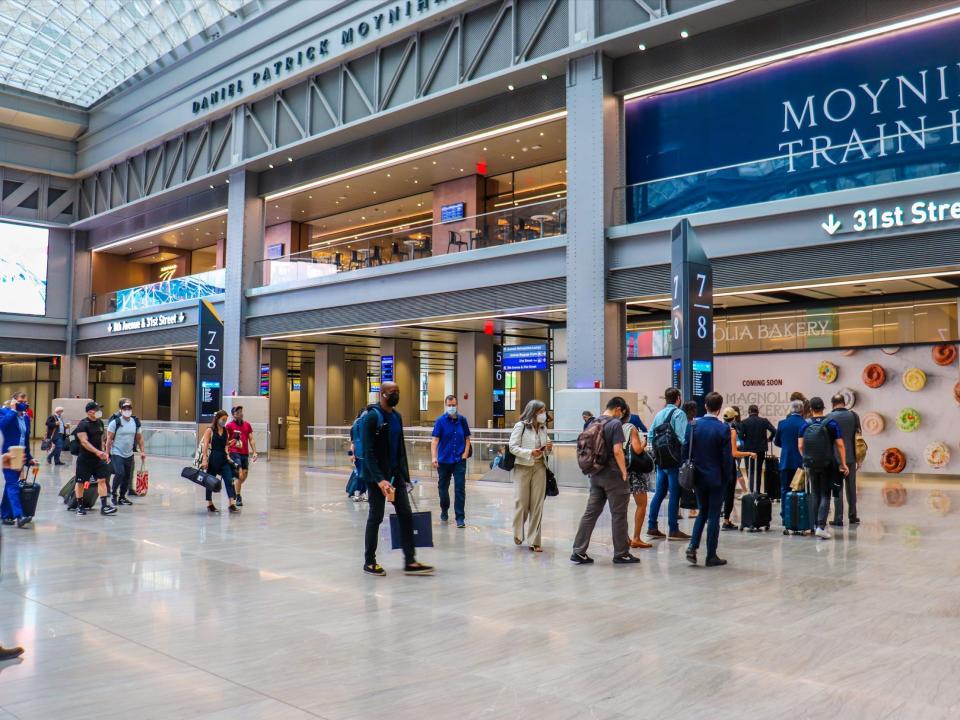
[0,458,960,720]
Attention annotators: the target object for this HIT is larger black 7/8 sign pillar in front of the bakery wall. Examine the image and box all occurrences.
[670,220,713,415]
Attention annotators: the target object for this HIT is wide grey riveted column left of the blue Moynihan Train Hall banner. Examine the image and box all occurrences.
[567,52,626,388]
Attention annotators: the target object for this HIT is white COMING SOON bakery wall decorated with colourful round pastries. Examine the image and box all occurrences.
[627,343,960,477]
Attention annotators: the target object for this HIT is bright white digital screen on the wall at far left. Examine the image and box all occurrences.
[0,223,47,315]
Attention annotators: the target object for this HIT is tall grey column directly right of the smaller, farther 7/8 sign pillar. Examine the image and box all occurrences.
[223,170,264,395]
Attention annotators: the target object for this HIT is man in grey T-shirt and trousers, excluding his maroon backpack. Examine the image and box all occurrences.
[570,396,640,565]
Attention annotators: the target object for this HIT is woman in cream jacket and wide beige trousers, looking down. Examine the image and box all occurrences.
[510,400,553,552]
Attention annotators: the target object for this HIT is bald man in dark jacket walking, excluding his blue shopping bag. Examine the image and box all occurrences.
[360,382,433,577]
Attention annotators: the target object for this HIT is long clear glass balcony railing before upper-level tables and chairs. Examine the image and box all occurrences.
[256,198,567,286]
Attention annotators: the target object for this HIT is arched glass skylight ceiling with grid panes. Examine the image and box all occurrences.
[0,0,248,107]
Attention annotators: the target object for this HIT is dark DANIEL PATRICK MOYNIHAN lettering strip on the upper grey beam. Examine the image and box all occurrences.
[191,0,448,115]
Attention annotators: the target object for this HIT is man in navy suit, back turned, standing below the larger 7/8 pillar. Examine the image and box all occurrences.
[681,392,735,567]
